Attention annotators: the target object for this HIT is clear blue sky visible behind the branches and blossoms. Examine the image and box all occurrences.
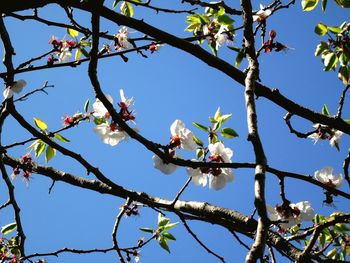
[0,1,350,263]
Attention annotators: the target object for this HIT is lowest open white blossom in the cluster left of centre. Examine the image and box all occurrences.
[94,123,129,146]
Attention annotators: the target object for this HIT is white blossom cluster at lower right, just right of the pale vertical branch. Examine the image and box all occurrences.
[266,201,315,233]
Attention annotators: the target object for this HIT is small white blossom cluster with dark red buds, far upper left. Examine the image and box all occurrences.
[47,36,77,65]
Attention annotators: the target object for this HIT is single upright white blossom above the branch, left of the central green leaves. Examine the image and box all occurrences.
[170,120,197,150]
